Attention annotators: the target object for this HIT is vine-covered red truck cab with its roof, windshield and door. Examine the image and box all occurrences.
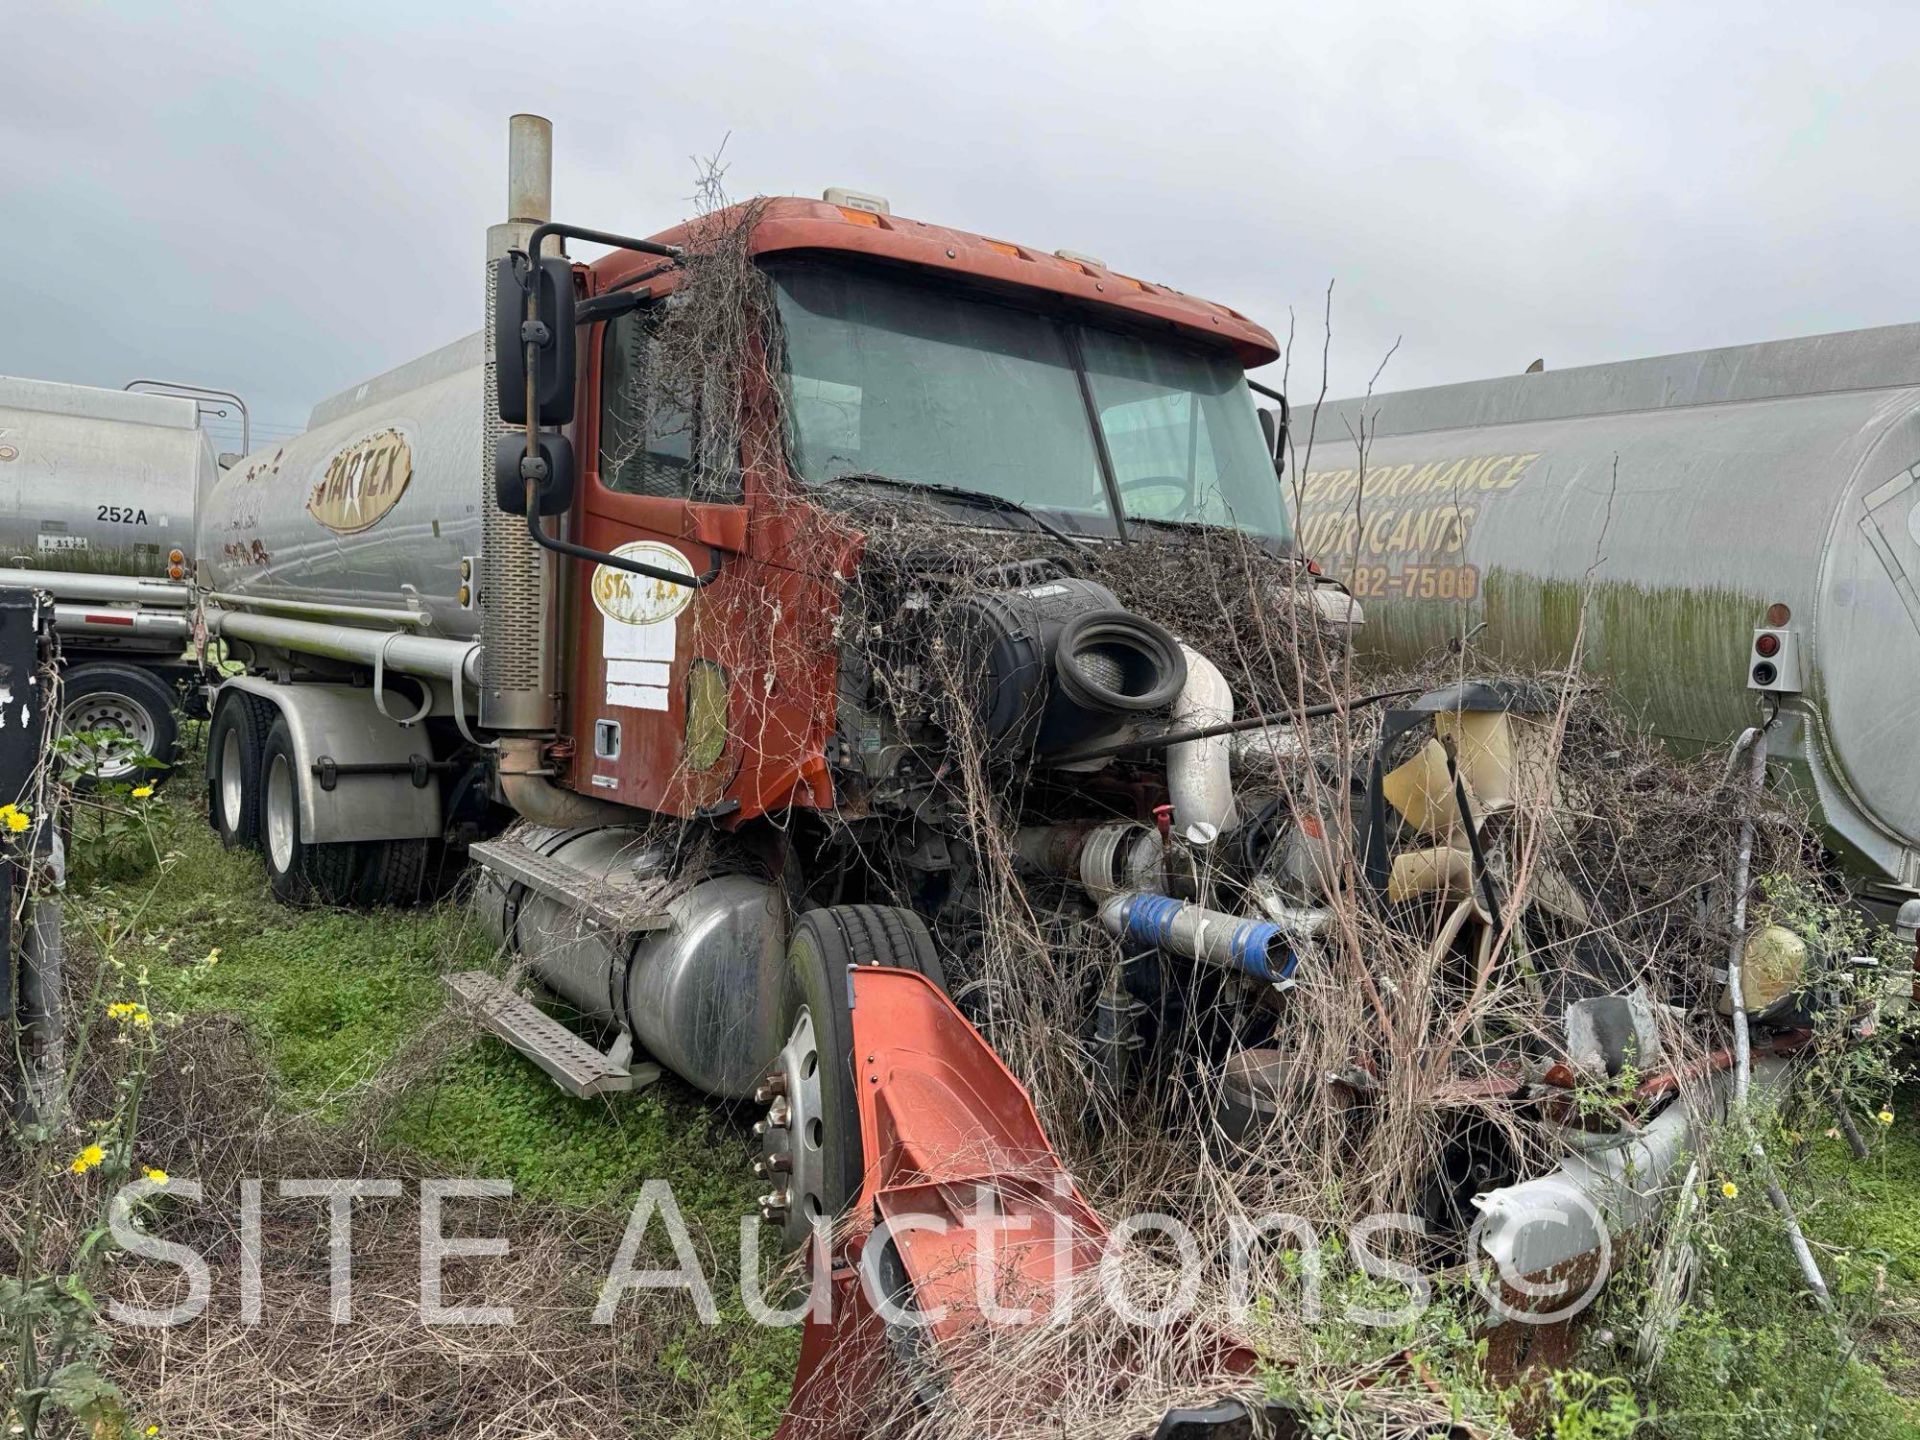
[533,198,1290,822]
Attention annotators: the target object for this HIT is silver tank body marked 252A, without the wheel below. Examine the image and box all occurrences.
[0,376,217,580]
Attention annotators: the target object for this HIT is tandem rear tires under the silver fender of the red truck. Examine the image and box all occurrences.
[207,691,430,906]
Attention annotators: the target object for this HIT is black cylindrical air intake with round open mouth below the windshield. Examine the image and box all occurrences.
[948,578,1187,758]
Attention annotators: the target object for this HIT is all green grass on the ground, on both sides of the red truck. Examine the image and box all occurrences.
[75,776,1920,1440]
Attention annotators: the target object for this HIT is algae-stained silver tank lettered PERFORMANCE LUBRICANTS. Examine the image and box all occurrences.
[1288,324,1920,887]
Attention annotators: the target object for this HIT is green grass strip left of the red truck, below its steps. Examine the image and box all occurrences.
[69,774,799,1440]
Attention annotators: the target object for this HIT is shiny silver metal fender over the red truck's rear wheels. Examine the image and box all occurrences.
[213,676,444,845]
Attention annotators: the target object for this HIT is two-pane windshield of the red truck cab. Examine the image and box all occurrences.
[772,261,1290,540]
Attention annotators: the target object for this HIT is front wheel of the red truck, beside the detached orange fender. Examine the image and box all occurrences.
[762,904,947,1248]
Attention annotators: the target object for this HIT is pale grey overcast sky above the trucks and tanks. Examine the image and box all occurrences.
[0,0,1920,451]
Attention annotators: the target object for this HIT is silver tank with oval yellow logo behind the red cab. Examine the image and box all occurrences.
[198,334,484,639]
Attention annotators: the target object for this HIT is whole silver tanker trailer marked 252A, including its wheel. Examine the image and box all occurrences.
[0,376,219,778]
